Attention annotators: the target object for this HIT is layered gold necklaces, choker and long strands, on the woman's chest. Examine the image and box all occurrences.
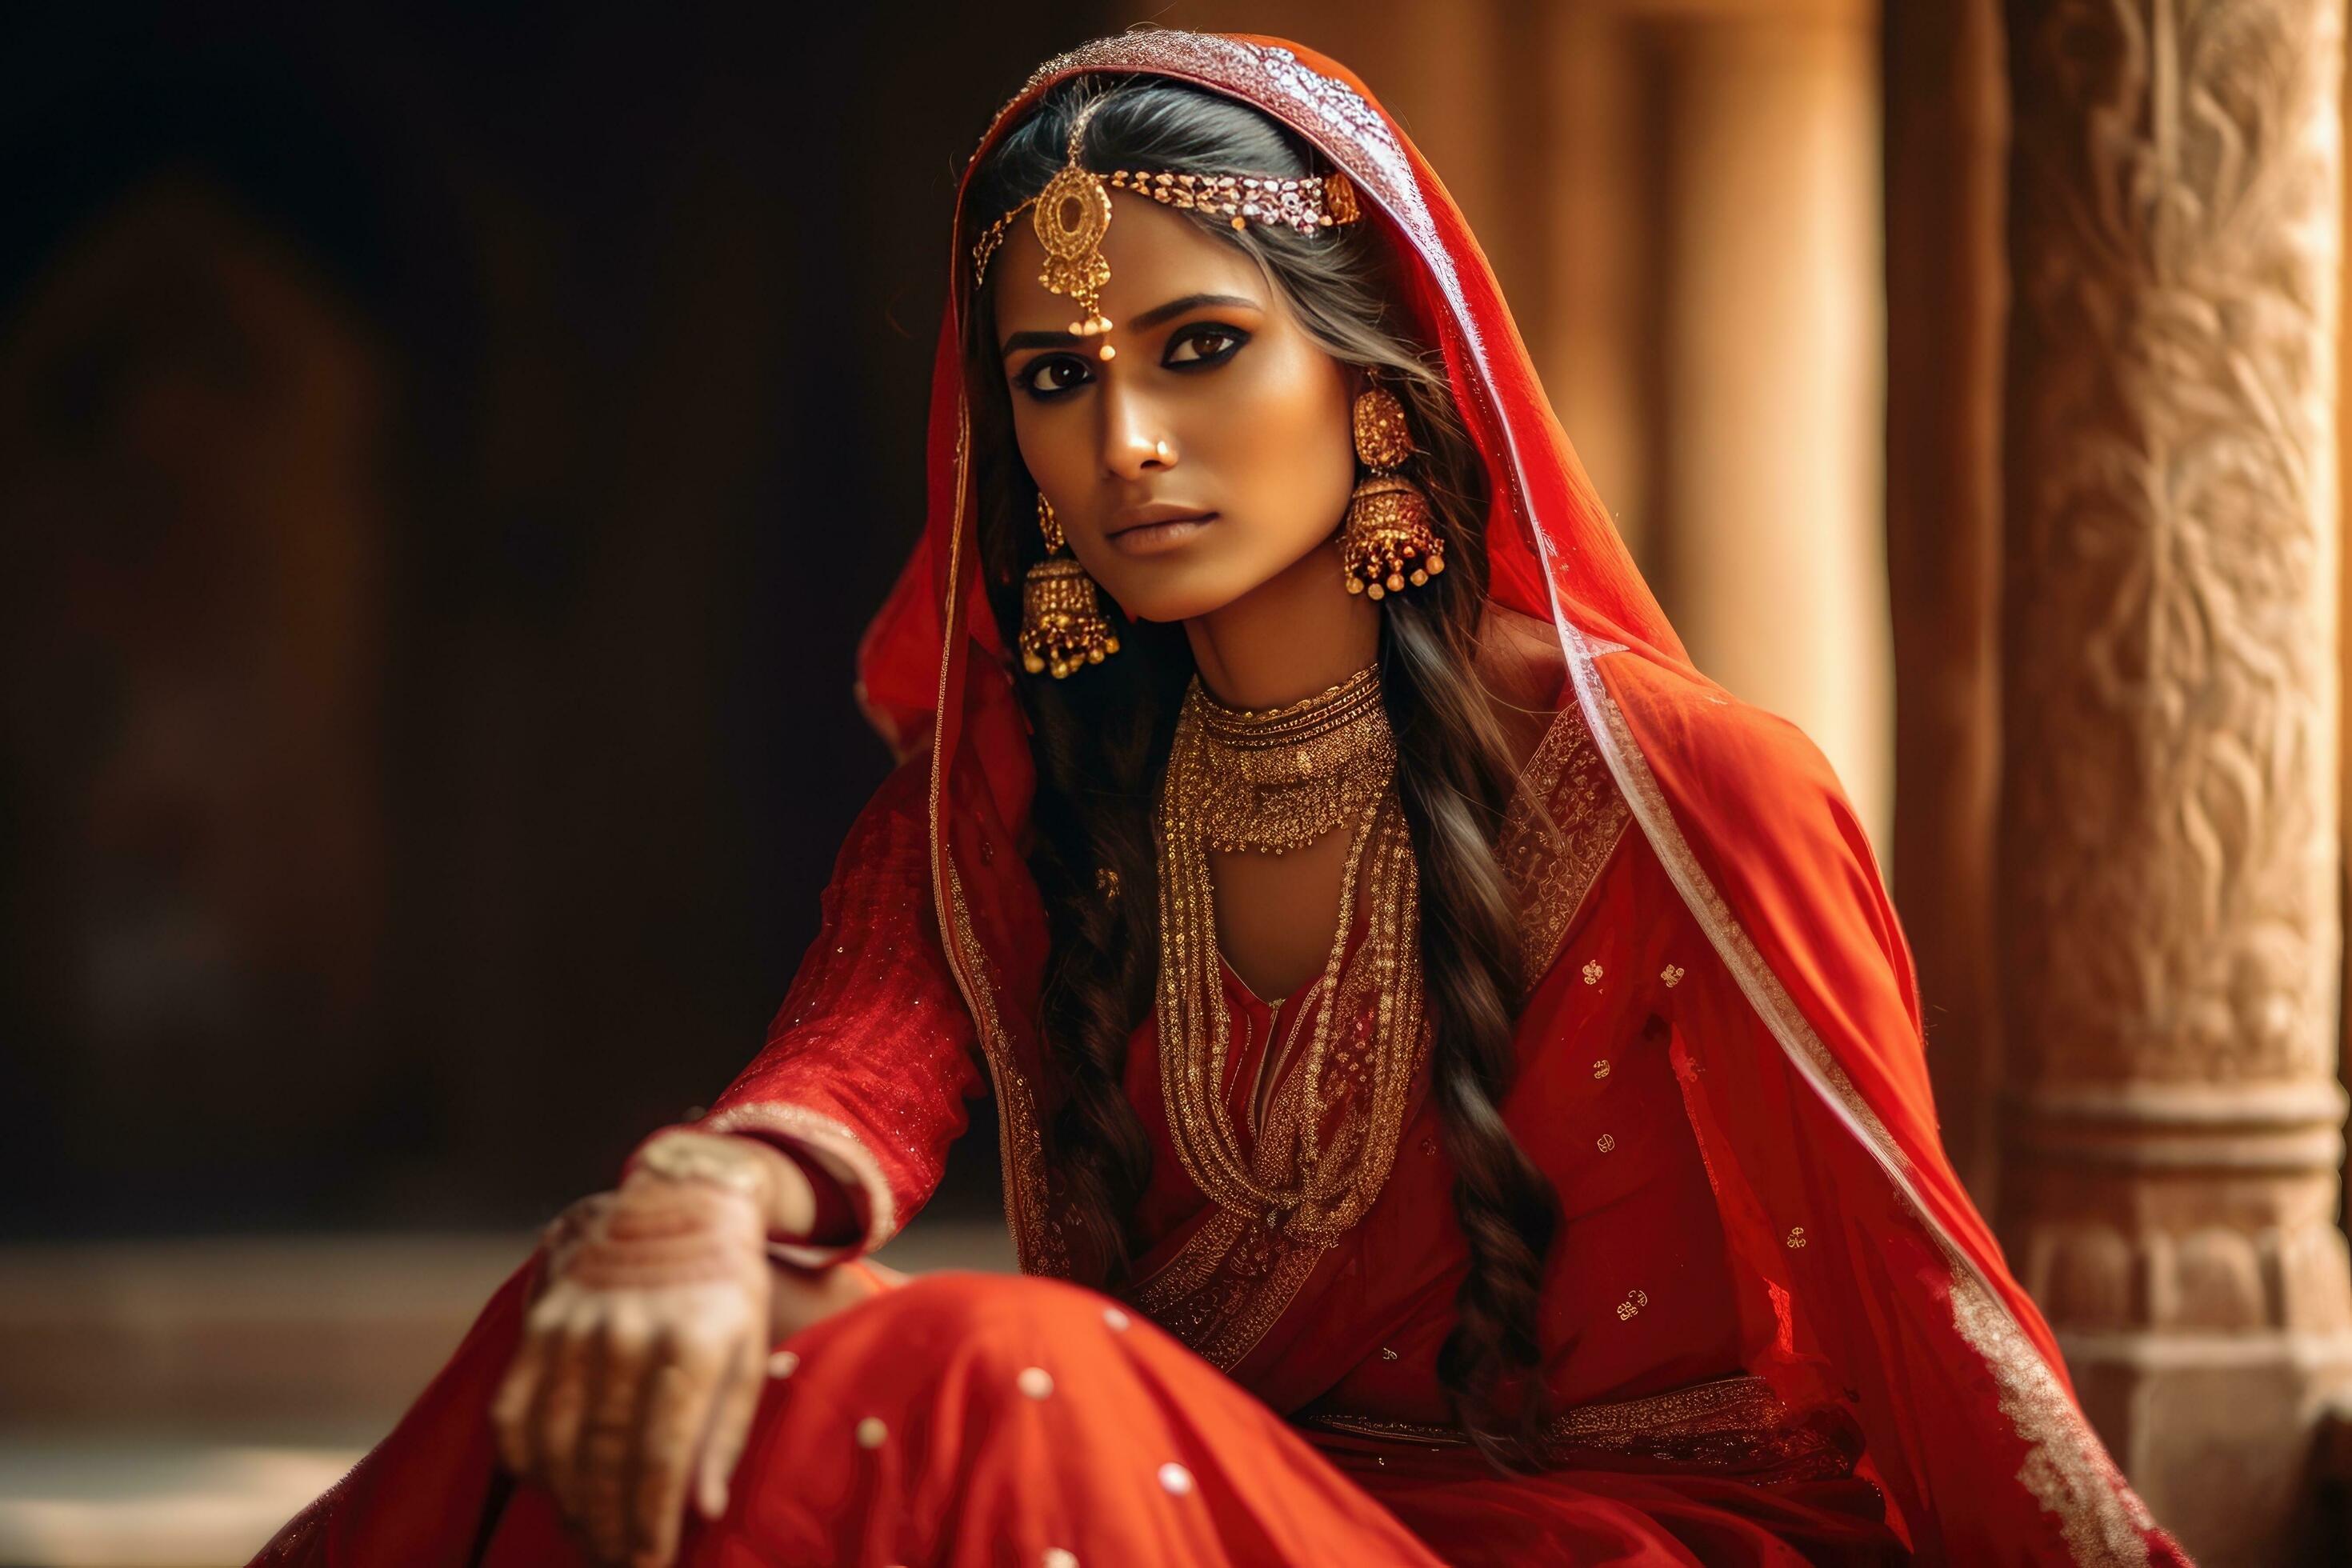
[1155,668,1428,1241]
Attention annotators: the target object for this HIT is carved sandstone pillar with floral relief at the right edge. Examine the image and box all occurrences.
[1994,0,2352,1563]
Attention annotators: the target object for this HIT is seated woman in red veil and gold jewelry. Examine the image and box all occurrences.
[261,33,2182,1563]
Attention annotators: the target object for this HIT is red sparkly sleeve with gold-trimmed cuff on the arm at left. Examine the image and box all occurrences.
[640,757,986,1267]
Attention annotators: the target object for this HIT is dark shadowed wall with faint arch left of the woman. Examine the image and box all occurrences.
[0,5,1101,1239]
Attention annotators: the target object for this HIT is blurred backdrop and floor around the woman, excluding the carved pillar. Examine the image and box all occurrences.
[0,0,2340,1563]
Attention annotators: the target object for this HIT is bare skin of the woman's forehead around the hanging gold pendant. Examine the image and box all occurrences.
[988,190,1273,334]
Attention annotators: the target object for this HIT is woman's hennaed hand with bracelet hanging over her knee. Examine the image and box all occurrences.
[491,1133,814,1568]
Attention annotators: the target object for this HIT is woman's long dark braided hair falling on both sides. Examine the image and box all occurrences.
[962,75,1559,1470]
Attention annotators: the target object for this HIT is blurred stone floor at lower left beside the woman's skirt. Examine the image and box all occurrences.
[0,1215,1014,1568]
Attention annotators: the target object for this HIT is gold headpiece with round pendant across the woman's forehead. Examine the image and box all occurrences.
[971,94,1364,360]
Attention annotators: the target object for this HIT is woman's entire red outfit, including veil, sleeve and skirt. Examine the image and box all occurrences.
[258,30,2185,1563]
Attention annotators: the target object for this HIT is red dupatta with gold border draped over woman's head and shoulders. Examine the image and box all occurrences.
[858,30,2185,1563]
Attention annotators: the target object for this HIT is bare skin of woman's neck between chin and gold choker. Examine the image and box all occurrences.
[1183,546,1381,707]
